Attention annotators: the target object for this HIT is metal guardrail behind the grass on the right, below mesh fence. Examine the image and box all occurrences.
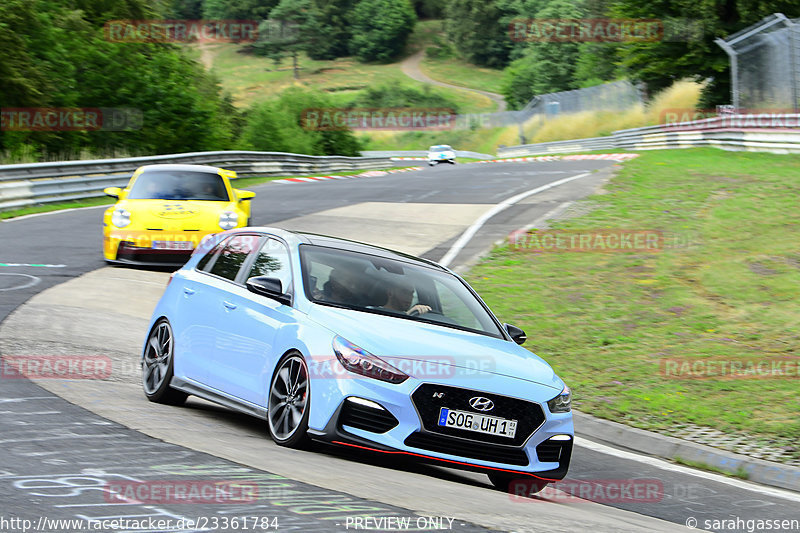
[498,113,800,157]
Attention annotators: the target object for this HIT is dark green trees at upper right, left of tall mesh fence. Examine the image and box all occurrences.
[442,0,800,108]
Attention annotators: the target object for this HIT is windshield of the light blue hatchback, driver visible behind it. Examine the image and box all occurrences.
[300,245,503,338]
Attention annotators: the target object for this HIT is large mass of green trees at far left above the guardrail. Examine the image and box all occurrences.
[0,0,236,158]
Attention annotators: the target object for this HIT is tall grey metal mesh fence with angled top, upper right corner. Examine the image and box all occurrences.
[716,13,800,111]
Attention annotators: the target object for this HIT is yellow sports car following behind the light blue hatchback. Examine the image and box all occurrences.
[103,161,255,265]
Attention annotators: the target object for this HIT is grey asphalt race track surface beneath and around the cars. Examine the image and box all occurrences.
[0,161,800,532]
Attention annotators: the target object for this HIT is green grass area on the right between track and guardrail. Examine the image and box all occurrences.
[469,148,800,444]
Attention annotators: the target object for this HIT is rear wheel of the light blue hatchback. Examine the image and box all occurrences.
[142,318,189,405]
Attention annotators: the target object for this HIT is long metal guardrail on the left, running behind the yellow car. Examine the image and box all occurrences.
[0,151,394,209]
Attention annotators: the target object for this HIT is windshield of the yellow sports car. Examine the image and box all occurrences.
[128,170,229,202]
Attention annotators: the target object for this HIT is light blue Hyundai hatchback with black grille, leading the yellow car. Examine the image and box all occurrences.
[142,228,573,493]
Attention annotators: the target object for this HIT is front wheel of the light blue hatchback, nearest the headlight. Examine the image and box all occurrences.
[267,352,311,448]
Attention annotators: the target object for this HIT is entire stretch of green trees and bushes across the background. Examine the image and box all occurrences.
[0,0,800,157]
